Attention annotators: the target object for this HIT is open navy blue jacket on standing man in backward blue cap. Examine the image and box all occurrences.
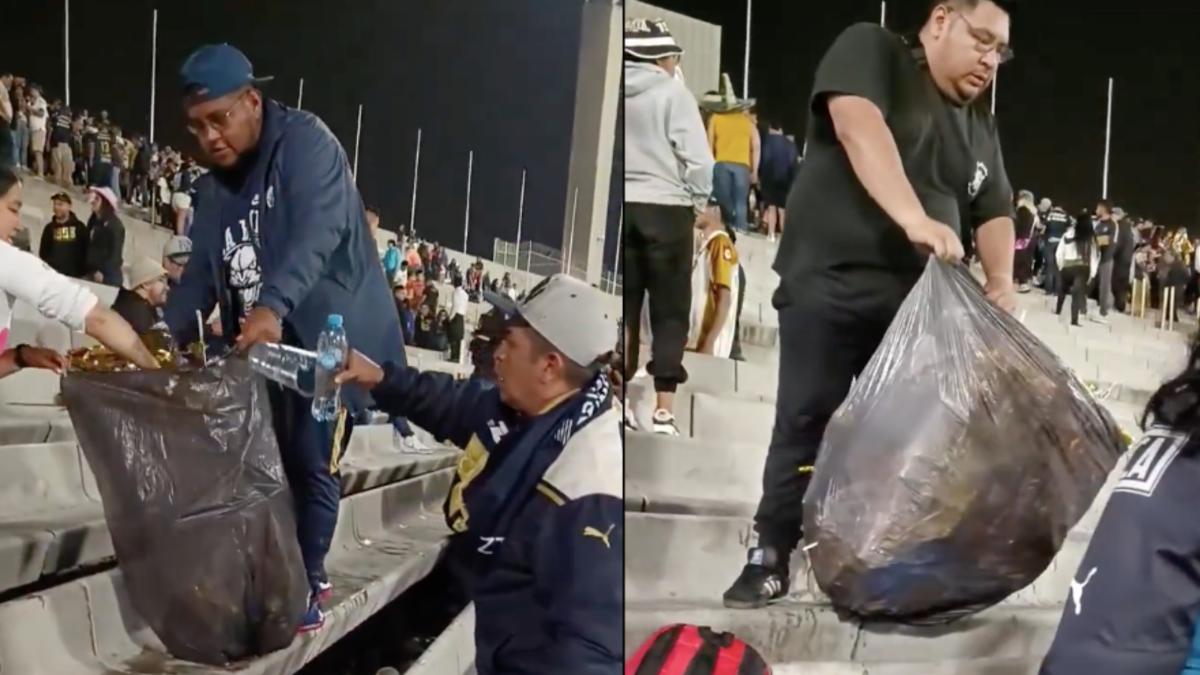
[163,101,404,393]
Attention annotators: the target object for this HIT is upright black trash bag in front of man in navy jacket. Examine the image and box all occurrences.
[62,359,308,665]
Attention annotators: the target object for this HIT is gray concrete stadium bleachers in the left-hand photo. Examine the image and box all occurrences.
[0,174,501,675]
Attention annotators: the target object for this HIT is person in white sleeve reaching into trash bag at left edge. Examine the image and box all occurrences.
[0,167,158,377]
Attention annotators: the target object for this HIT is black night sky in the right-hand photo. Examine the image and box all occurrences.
[649,0,1200,225]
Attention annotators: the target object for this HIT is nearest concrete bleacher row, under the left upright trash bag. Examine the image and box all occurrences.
[0,470,451,675]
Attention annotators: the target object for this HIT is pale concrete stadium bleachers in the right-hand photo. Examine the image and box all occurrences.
[625,235,1194,675]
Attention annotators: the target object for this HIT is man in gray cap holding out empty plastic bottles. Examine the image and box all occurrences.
[337,274,619,675]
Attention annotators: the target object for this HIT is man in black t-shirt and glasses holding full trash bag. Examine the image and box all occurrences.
[725,0,1015,609]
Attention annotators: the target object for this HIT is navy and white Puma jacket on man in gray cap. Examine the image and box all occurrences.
[372,364,625,675]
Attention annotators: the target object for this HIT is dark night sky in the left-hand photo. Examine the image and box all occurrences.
[0,0,619,267]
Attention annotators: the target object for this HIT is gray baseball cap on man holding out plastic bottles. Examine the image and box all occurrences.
[484,274,617,366]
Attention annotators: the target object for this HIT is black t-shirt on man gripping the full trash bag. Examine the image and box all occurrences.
[775,24,1013,288]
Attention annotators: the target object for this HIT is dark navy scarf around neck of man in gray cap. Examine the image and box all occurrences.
[463,371,612,550]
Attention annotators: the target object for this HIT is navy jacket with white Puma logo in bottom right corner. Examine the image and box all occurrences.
[1040,426,1200,675]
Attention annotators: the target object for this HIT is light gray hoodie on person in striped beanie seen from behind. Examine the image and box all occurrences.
[625,62,713,209]
